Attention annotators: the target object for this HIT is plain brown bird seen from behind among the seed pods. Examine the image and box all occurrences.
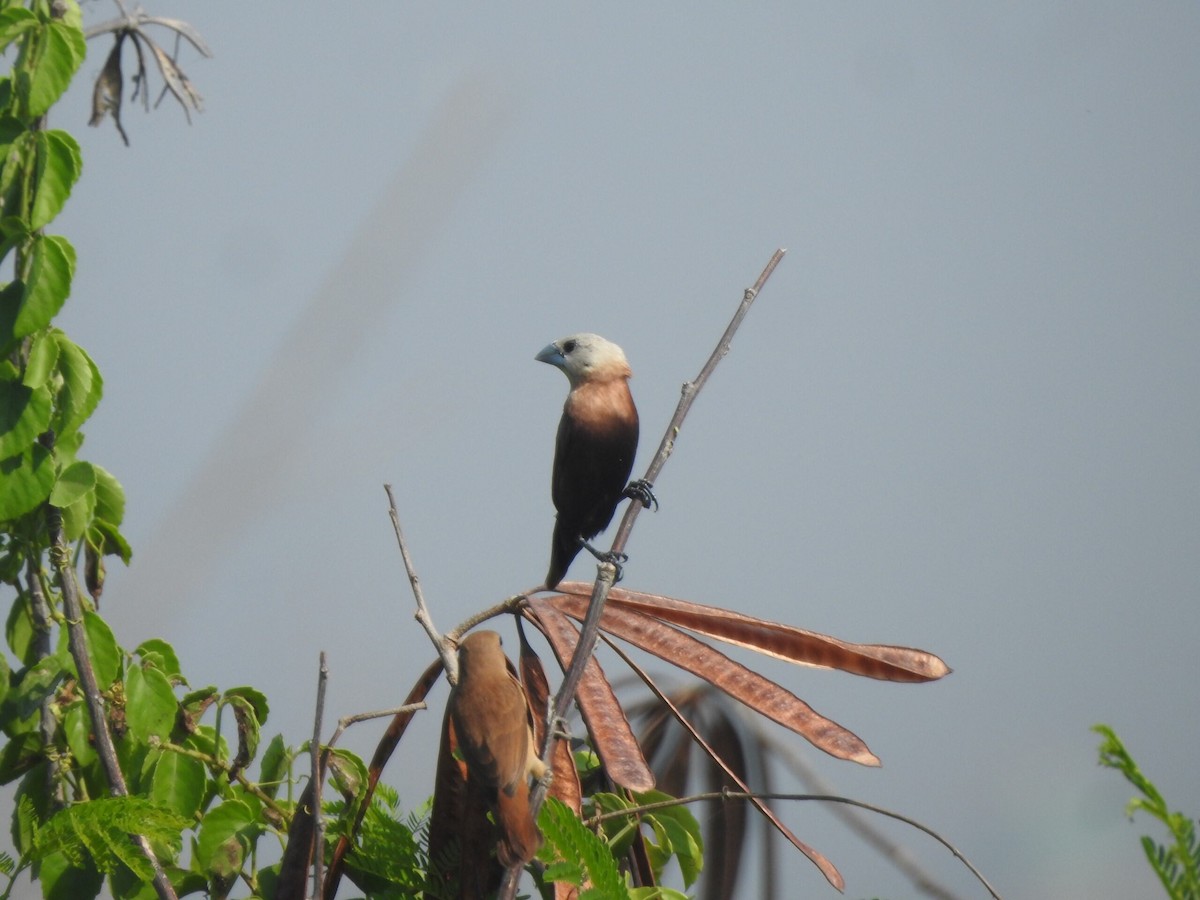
[446,631,546,868]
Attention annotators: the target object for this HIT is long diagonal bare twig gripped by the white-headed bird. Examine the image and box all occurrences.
[497,248,787,900]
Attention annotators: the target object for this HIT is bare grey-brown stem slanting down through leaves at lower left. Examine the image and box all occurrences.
[46,506,175,900]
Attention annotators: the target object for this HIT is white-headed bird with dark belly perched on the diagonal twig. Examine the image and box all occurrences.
[534,332,654,589]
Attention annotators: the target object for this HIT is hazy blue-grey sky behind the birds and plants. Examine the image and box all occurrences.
[18,0,1200,900]
